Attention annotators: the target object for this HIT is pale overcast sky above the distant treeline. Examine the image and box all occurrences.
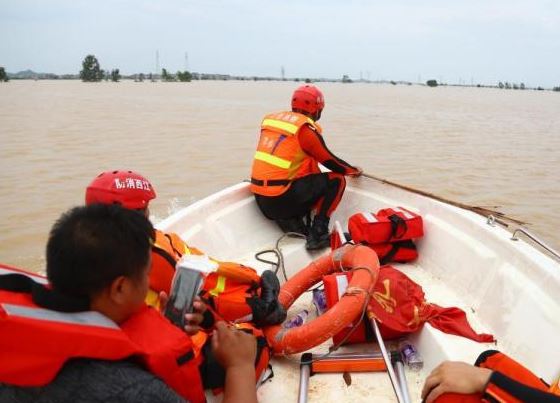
[0,0,560,87]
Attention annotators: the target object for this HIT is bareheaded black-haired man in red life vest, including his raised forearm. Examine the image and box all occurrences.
[0,204,256,402]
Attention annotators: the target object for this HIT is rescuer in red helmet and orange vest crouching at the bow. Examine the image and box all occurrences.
[251,84,362,250]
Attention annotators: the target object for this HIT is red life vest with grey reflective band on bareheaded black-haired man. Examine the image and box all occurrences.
[0,268,206,402]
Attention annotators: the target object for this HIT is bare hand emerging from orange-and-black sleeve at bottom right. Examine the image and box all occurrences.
[422,361,492,403]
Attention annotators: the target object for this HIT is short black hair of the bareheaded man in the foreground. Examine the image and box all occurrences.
[47,204,154,298]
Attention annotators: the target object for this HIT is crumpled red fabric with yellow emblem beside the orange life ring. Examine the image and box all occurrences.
[323,266,494,342]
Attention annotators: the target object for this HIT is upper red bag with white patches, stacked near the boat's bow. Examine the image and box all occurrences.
[348,207,424,245]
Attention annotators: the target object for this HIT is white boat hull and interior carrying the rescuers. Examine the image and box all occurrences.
[157,177,560,402]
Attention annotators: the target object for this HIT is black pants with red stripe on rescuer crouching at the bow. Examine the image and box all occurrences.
[255,172,346,220]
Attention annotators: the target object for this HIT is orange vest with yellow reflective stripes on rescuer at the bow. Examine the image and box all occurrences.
[250,111,322,196]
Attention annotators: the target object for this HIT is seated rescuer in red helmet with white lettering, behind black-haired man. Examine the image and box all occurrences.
[85,170,286,327]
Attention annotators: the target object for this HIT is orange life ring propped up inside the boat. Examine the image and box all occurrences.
[264,245,379,355]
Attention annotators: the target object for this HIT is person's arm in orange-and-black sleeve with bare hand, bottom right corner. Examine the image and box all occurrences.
[422,350,560,403]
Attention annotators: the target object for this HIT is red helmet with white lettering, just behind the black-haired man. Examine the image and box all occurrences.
[86,171,156,210]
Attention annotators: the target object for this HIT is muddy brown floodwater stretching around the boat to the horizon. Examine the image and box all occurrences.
[0,81,560,270]
